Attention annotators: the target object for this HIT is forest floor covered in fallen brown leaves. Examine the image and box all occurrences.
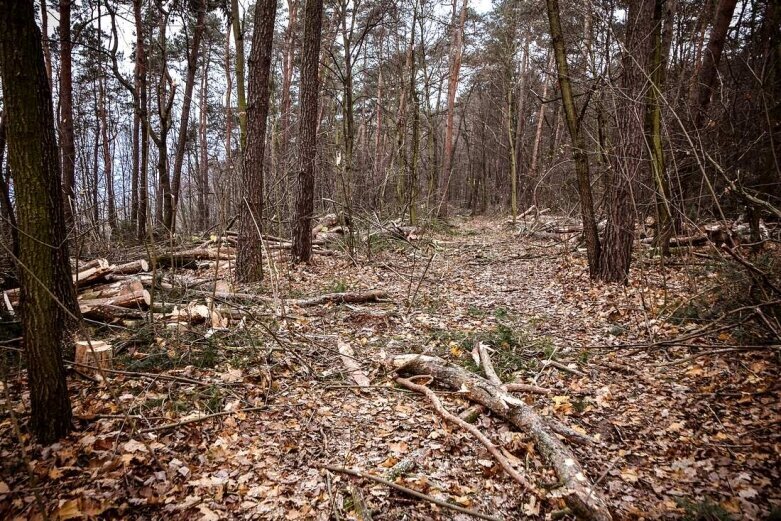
[0,214,781,520]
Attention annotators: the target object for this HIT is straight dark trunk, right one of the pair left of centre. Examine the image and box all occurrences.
[291,0,323,262]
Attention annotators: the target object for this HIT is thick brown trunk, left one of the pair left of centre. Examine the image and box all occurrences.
[236,0,277,282]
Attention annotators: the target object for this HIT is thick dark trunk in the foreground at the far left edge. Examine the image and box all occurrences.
[0,0,78,443]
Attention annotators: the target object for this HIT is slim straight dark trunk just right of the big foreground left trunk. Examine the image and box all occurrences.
[58,0,76,225]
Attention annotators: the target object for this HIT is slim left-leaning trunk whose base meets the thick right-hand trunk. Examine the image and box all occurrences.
[547,0,601,279]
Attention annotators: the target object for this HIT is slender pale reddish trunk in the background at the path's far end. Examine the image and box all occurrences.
[437,0,467,219]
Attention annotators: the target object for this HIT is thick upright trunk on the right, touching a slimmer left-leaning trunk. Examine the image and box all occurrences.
[599,0,654,283]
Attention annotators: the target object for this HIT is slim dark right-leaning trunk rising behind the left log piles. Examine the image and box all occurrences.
[169,0,206,233]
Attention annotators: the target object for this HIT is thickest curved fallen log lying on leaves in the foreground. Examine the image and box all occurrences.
[392,355,612,521]
